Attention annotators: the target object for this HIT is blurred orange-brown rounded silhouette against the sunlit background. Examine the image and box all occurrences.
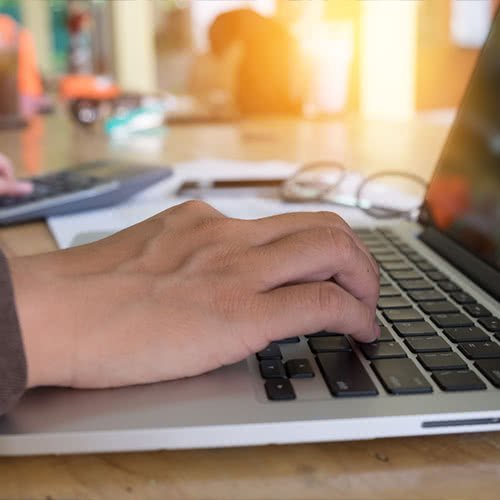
[190,0,322,115]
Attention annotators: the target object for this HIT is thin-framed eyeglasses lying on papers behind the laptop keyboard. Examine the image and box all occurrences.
[281,161,427,219]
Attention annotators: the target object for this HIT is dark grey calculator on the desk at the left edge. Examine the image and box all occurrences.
[0,160,172,225]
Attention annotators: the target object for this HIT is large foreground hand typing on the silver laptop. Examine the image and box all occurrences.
[10,201,380,388]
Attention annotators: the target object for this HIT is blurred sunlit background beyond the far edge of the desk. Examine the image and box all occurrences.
[0,0,500,124]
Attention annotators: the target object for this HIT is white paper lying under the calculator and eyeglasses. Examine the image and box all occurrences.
[47,159,406,248]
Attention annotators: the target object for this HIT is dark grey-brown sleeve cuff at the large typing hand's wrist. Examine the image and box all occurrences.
[0,251,27,415]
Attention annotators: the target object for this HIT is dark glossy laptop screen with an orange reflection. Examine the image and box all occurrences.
[421,16,500,270]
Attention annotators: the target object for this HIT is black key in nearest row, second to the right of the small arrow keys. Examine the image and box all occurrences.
[372,358,432,394]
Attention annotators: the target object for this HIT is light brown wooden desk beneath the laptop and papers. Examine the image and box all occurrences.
[0,113,500,500]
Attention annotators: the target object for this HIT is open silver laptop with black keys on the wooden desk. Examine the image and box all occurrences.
[0,17,500,455]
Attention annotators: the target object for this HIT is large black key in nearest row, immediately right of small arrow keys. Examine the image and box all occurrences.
[317,352,378,397]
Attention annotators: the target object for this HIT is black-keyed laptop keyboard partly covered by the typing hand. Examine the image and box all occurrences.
[256,229,500,401]
